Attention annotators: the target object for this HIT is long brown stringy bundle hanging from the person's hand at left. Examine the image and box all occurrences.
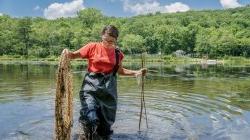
[55,53,73,140]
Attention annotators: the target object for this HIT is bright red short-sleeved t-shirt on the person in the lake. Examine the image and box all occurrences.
[79,42,124,74]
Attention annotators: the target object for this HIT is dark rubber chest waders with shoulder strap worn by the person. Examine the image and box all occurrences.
[79,49,120,139]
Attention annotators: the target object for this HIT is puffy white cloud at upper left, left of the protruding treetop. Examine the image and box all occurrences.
[43,0,84,19]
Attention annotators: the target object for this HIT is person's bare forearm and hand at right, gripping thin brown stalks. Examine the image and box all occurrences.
[118,64,147,76]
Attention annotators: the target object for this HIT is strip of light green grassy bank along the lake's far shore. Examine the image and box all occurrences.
[0,54,250,65]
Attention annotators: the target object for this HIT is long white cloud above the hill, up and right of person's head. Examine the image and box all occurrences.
[123,0,190,15]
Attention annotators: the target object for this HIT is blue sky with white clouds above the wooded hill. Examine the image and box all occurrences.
[0,0,250,19]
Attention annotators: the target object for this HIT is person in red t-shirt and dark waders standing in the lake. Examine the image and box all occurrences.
[63,25,147,139]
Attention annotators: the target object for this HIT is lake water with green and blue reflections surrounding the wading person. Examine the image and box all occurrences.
[0,63,250,140]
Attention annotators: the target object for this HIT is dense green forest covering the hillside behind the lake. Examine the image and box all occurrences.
[0,6,250,58]
